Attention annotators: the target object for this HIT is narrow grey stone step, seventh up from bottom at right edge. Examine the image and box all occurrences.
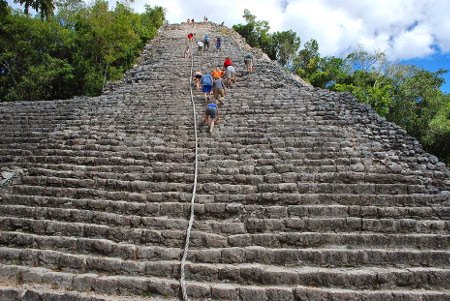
[5,182,449,207]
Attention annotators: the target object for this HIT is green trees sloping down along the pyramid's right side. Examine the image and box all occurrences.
[233,10,450,165]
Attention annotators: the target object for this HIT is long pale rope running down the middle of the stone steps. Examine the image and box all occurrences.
[180,43,198,301]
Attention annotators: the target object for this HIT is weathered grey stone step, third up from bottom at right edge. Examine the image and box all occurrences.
[0,231,450,268]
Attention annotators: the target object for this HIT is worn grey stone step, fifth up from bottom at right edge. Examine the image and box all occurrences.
[0,205,450,235]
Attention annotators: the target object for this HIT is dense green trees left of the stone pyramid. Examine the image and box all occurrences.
[0,0,164,101]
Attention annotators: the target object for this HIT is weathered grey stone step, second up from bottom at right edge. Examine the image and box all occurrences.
[0,253,450,290]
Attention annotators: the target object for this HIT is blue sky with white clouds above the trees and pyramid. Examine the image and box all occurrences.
[7,0,450,93]
